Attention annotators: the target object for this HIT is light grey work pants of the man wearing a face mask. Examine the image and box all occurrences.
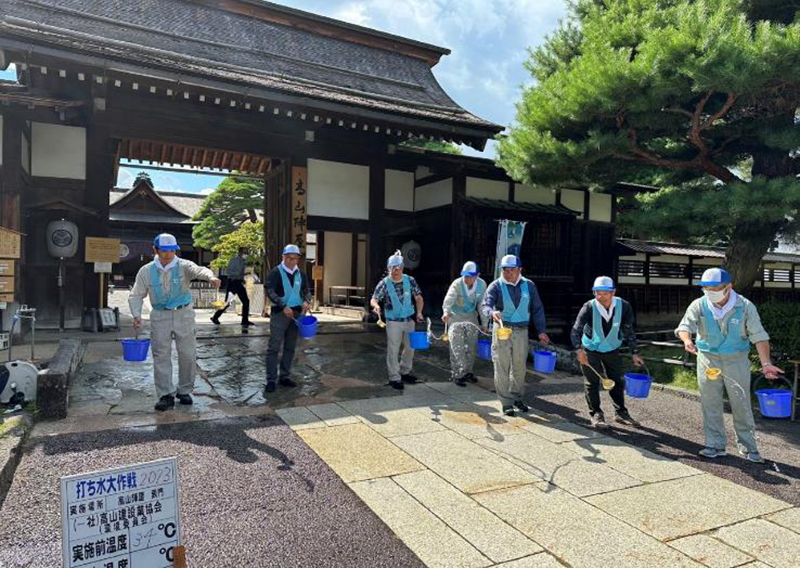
[697,352,758,452]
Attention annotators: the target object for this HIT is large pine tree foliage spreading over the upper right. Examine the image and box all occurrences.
[498,0,800,289]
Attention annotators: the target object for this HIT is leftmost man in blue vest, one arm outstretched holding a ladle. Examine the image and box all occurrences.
[128,233,220,411]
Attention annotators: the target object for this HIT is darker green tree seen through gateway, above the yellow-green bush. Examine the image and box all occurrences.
[192,176,264,250]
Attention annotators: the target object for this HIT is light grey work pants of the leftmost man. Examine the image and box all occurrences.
[150,306,197,398]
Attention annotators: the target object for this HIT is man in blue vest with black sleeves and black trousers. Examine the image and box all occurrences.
[572,276,644,429]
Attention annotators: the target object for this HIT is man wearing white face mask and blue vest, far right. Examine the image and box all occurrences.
[675,268,783,463]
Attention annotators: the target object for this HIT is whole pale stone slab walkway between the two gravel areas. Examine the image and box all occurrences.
[277,382,800,568]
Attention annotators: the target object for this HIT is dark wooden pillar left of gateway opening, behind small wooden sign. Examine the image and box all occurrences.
[83,126,117,308]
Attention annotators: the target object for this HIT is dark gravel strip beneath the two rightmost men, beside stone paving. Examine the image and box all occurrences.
[526,375,800,506]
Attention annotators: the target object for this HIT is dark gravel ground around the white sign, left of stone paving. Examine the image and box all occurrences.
[0,417,423,568]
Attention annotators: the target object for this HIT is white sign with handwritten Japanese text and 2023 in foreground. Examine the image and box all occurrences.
[61,457,181,568]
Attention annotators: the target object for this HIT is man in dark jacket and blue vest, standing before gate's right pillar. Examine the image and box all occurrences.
[264,245,311,394]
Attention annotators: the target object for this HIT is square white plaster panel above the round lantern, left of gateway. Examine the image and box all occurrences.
[31,122,86,179]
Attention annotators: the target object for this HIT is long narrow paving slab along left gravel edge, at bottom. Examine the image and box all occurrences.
[350,479,493,568]
